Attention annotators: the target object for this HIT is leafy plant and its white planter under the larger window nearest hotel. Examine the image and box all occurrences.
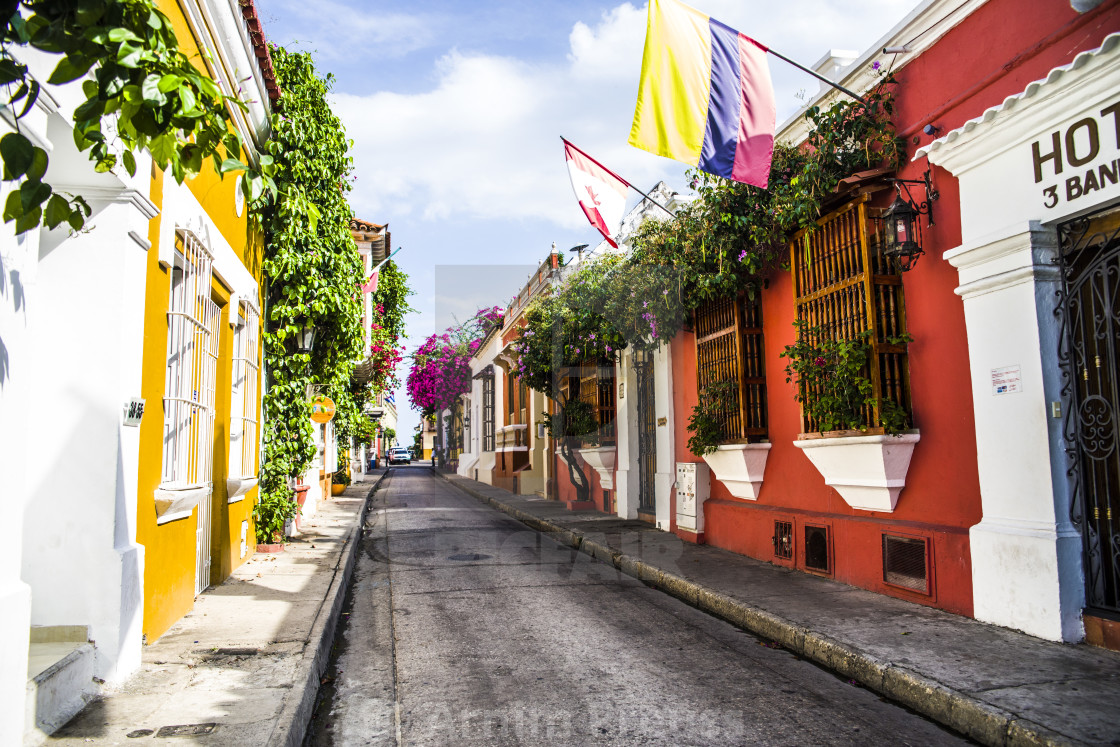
[782,320,920,512]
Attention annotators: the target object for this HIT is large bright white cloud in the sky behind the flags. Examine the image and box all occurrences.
[333,0,914,228]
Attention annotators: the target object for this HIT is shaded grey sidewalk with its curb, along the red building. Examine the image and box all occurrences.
[437,473,1120,745]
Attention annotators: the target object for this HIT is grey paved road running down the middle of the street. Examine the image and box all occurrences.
[308,466,963,746]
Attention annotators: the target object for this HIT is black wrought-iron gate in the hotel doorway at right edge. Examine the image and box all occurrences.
[1057,208,1120,615]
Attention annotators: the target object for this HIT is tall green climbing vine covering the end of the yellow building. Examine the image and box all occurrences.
[254,46,358,542]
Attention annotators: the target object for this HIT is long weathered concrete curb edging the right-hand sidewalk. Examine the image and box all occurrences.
[432,477,1081,747]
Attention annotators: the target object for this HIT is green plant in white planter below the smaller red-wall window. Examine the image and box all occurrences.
[689,379,771,501]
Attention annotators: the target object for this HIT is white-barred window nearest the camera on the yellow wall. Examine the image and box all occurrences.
[161,230,221,488]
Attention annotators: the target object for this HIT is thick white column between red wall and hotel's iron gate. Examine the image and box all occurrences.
[945,222,1083,641]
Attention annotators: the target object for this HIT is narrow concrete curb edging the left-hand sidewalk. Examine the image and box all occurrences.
[268,469,389,747]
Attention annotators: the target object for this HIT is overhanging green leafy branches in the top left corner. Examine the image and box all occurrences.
[0,0,276,233]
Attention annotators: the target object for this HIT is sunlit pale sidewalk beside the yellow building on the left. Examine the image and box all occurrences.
[47,469,386,747]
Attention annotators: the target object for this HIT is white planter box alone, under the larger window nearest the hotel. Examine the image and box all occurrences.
[793,432,921,512]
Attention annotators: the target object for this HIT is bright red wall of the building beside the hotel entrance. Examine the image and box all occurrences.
[672,0,1120,615]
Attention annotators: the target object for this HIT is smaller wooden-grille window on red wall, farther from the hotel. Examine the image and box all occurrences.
[696,293,767,443]
